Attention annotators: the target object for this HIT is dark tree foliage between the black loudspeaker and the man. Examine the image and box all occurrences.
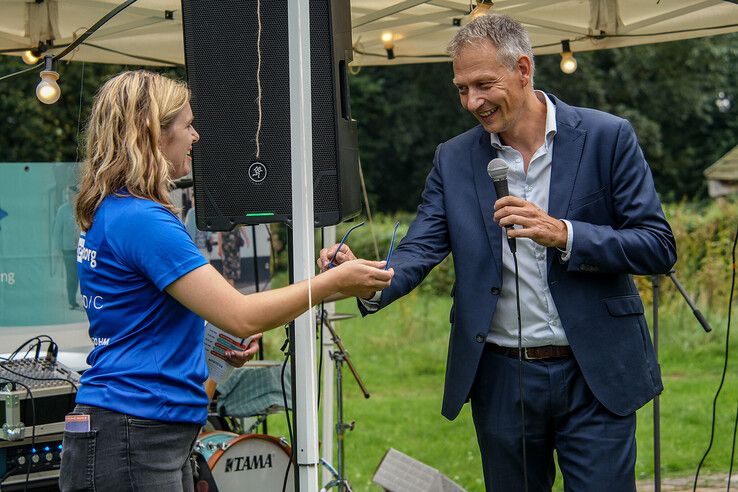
[351,63,475,213]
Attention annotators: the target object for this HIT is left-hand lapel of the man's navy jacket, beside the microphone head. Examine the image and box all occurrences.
[470,131,502,275]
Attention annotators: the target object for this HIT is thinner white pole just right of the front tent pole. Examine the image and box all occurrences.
[320,226,336,484]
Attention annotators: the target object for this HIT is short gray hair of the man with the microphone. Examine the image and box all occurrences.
[446,14,535,77]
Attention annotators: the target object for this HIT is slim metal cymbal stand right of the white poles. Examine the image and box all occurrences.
[321,311,371,492]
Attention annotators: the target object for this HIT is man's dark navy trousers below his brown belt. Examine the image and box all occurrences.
[470,349,636,492]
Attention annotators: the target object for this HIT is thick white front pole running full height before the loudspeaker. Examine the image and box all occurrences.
[287,0,318,492]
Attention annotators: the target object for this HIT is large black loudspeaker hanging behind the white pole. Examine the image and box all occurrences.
[182,0,361,231]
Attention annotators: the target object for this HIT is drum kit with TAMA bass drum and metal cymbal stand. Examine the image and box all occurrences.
[193,312,360,492]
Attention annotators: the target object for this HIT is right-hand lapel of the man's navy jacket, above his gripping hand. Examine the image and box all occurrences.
[547,94,587,271]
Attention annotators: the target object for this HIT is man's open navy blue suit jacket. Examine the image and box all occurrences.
[360,95,676,419]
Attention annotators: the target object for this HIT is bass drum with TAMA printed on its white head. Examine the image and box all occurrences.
[195,431,295,492]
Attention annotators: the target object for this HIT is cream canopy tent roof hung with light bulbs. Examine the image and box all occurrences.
[0,0,738,65]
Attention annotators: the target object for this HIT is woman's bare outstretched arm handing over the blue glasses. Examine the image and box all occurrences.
[166,260,394,338]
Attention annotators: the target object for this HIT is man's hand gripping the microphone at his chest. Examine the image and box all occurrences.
[494,196,567,249]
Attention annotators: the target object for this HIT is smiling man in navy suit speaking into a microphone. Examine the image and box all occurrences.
[320,15,676,492]
